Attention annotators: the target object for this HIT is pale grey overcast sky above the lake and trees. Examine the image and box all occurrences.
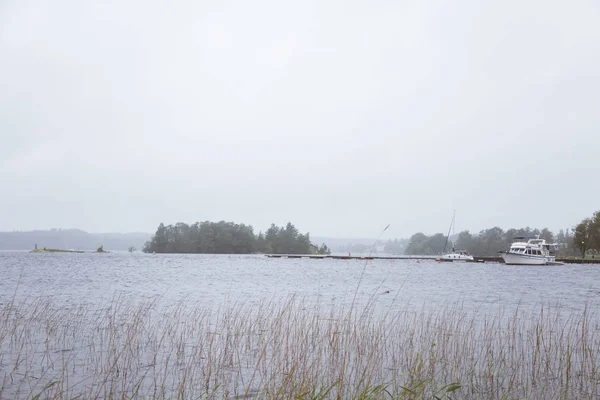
[0,0,600,238]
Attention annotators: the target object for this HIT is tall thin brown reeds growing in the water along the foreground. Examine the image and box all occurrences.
[0,297,600,399]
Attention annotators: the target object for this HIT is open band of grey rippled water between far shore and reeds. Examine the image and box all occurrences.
[0,252,600,312]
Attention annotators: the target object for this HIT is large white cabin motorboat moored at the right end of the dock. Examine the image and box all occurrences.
[499,236,563,265]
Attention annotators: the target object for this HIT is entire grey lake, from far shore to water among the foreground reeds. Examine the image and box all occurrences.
[0,252,600,398]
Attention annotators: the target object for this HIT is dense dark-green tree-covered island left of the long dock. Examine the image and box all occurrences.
[143,221,330,254]
